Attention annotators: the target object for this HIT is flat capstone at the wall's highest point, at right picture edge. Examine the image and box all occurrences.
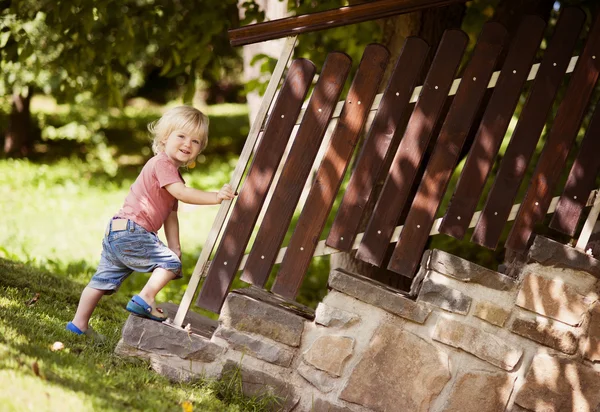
[529,235,600,279]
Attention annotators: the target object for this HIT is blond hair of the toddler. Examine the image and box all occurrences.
[148,106,208,154]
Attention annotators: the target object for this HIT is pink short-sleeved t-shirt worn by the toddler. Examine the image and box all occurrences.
[117,152,185,232]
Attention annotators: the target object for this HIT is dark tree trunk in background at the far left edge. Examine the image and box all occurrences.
[4,92,33,156]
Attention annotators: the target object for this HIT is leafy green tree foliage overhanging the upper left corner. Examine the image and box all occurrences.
[0,0,244,106]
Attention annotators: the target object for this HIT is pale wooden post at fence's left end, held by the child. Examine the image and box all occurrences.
[173,36,297,327]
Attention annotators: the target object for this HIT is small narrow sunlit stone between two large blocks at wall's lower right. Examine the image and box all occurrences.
[510,318,577,355]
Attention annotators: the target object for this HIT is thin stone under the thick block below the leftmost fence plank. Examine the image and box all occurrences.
[215,326,294,367]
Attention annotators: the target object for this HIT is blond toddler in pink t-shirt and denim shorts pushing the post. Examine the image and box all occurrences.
[67,106,234,335]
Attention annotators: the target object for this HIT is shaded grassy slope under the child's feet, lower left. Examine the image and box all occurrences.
[0,259,280,411]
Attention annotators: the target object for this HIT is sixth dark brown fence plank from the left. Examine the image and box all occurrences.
[388,22,507,278]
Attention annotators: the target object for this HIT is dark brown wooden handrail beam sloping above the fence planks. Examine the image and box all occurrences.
[228,0,467,46]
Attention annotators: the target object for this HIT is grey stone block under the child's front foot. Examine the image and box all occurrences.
[123,315,224,362]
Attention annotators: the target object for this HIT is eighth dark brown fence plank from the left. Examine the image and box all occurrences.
[471,8,585,249]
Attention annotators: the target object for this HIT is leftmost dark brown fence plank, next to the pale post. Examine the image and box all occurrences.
[196,59,316,312]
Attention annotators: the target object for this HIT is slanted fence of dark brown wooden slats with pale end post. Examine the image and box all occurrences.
[175,8,600,325]
